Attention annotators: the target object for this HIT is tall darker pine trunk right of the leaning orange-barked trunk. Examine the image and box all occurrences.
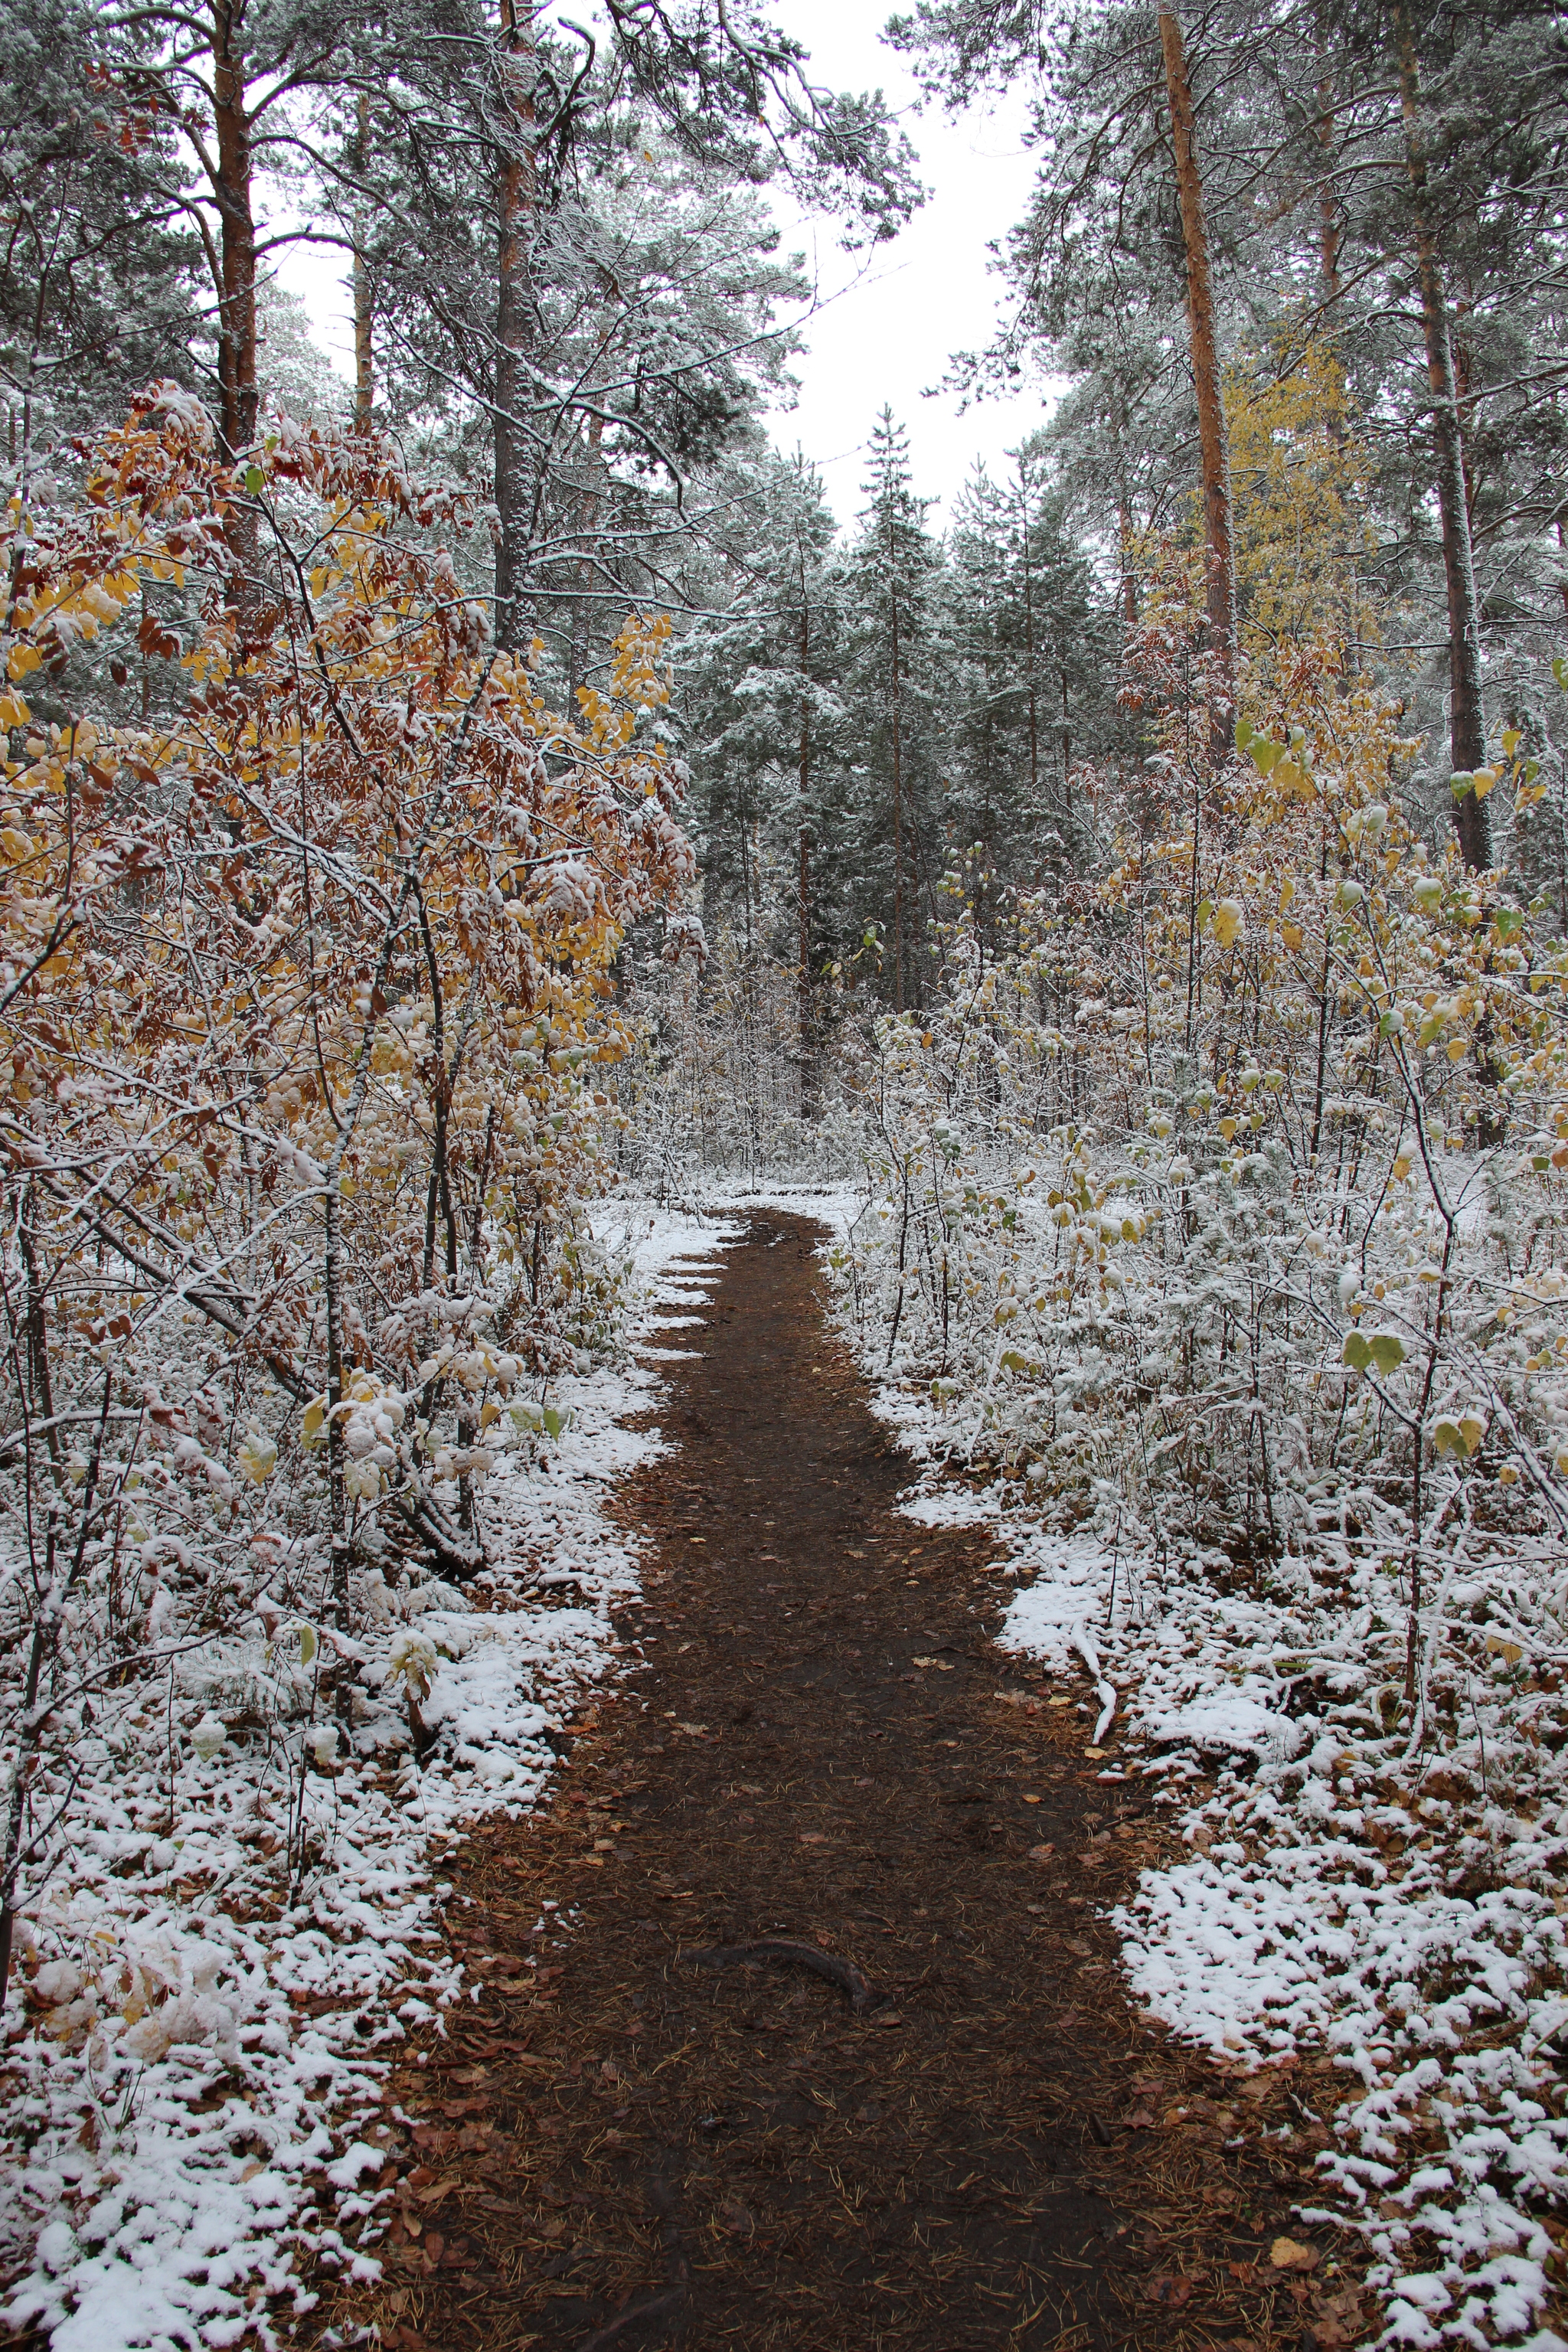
[1394,0,1493,873]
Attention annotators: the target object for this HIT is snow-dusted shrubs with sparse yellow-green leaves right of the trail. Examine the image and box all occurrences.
[835,649,1568,1707]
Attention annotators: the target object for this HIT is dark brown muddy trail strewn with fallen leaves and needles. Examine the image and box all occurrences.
[341,1211,1361,2352]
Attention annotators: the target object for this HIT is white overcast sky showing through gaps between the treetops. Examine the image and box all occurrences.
[279,0,1046,527]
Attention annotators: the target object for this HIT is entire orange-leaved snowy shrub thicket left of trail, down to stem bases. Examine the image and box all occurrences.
[0,388,691,1975]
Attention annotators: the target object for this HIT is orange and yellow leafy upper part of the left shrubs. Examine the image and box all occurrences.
[0,395,694,1580]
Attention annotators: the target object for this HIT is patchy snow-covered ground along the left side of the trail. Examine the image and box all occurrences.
[0,1207,729,2352]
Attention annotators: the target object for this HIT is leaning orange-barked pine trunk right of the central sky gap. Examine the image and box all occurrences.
[1159,9,1236,764]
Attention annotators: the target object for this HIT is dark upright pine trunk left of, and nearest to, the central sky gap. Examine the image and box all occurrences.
[494,0,538,654]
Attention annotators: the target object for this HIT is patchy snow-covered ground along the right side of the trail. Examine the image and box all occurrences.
[808,1289,1568,2352]
